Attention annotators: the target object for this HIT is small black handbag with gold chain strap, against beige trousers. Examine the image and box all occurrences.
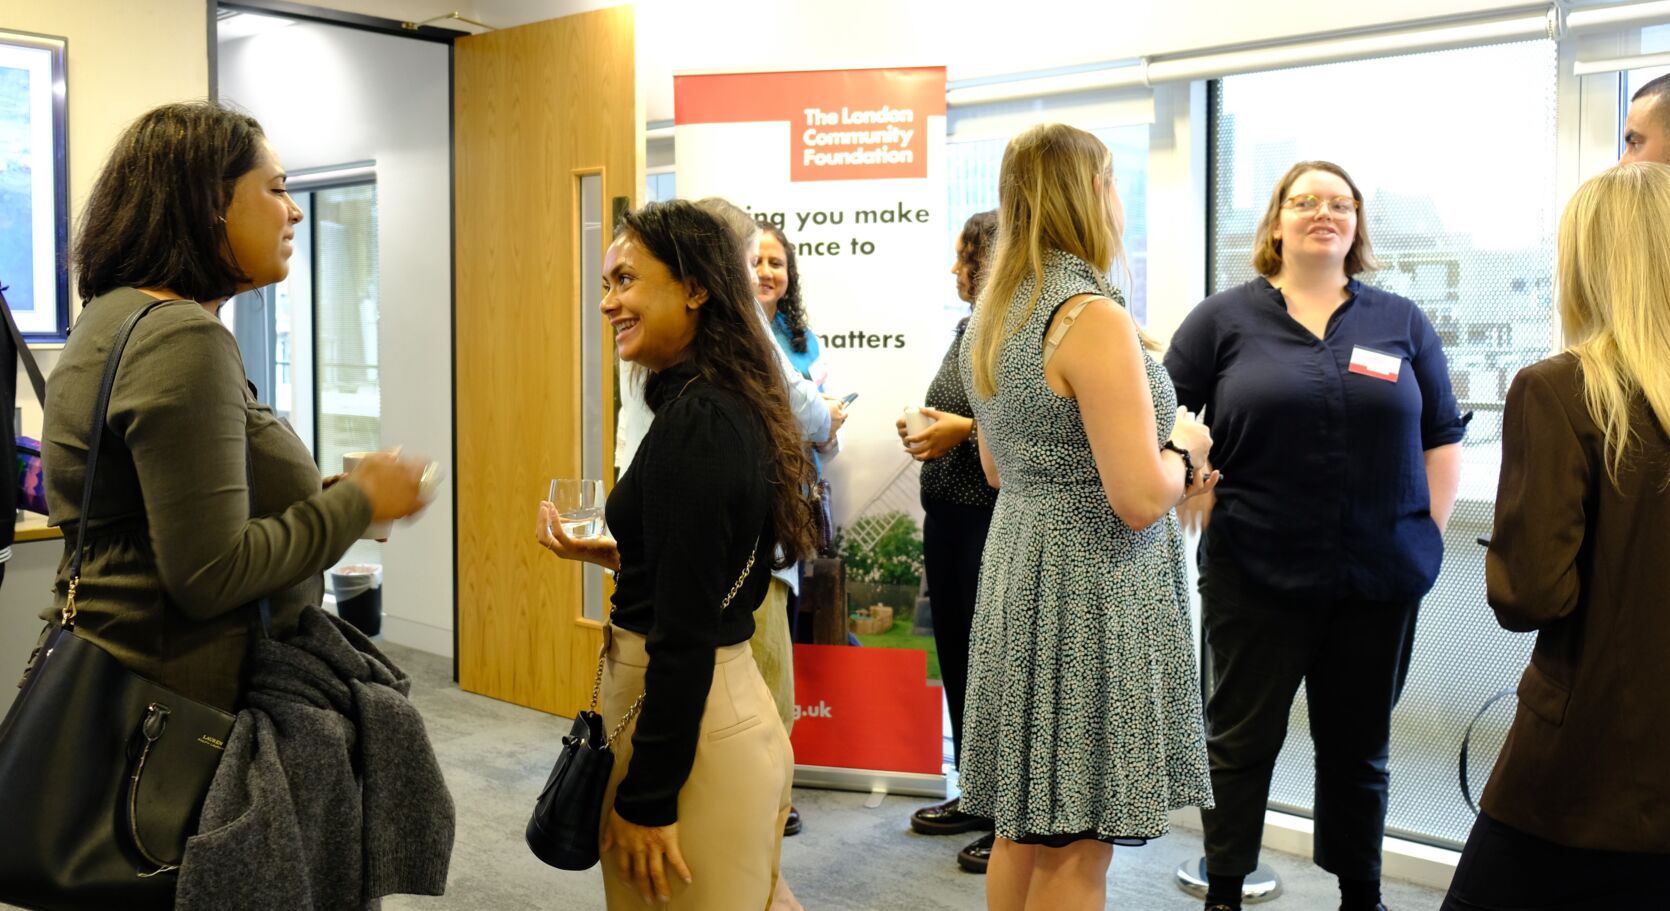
[526,539,760,869]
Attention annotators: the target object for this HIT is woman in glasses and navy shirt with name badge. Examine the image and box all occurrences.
[1166,162,1465,911]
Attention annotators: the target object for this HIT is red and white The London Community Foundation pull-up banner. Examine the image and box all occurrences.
[673,67,959,793]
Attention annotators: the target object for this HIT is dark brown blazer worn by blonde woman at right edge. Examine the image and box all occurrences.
[1481,354,1670,853]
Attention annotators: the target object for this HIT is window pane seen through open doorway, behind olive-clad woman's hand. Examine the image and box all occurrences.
[312,184,382,562]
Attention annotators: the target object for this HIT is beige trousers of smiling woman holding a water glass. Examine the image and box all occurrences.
[601,624,795,911]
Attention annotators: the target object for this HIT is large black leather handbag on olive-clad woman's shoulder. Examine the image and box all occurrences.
[0,300,250,911]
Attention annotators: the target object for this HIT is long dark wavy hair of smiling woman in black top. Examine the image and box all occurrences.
[615,200,817,569]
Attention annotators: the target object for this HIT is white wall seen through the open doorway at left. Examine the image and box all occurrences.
[219,23,453,656]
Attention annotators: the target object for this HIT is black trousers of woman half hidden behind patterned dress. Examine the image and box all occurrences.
[922,497,992,763]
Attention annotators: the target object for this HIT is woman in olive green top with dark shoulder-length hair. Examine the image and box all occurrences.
[42,103,423,709]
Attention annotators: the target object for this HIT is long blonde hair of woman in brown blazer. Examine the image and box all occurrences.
[1560,162,1670,486]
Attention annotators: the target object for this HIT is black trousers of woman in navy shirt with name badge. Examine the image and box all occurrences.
[1201,536,1420,879]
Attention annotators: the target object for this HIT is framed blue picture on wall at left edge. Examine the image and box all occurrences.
[0,28,70,342]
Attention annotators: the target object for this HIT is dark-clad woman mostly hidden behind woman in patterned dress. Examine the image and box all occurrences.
[897,212,997,873]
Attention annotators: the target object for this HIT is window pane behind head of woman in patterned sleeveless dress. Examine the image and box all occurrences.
[945,123,1149,322]
